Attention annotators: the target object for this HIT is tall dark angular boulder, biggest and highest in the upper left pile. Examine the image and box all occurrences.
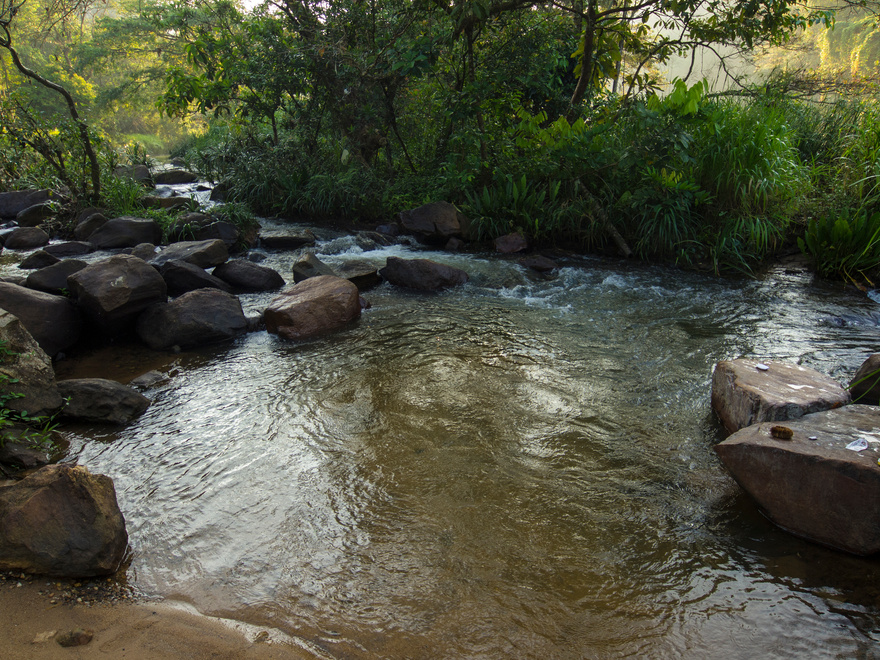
[67,254,168,335]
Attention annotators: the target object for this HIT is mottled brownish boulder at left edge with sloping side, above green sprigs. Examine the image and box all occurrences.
[0,310,63,416]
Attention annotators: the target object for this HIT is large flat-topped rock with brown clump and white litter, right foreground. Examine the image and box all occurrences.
[715,405,880,555]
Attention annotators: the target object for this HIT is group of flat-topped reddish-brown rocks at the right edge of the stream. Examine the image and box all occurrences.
[712,355,880,556]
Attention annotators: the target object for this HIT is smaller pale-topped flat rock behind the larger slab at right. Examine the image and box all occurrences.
[712,359,850,433]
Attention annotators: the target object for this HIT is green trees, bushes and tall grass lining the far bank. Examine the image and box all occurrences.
[0,0,880,282]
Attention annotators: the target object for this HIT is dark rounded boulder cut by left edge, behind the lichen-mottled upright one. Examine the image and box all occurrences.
[0,282,82,355]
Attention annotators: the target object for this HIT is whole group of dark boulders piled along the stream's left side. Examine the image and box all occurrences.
[0,189,556,576]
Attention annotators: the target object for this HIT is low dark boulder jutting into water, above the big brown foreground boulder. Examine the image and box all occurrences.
[58,378,150,424]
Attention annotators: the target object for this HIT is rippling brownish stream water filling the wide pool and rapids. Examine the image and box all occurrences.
[43,223,880,658]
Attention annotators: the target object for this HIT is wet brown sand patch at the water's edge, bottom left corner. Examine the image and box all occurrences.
[0,581,316,660]
